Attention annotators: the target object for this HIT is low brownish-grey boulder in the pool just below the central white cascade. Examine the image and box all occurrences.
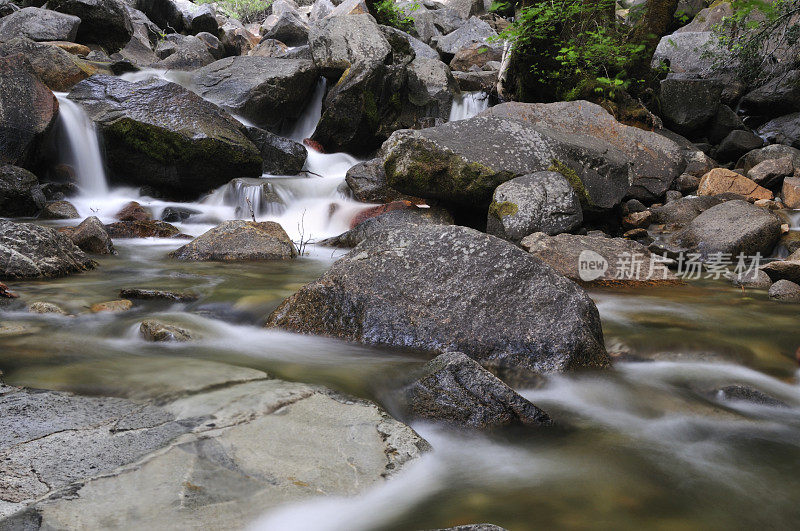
[169,220,298,262]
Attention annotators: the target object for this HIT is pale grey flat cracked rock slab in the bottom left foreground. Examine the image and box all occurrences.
[0,379,429,529]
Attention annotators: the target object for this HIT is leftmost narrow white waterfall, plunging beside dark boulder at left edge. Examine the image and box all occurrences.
[56,93,108,196]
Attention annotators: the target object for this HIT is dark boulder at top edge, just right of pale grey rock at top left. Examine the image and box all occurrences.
[47,0,133,53]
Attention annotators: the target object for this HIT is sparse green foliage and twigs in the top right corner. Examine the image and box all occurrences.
[713,0,800,85]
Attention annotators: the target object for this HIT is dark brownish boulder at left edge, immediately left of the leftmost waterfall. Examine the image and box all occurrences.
[0,54,58,167]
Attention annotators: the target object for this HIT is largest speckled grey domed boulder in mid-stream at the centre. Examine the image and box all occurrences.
[266,225,608,377]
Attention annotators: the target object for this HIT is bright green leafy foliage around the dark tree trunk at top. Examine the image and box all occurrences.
[500,0,649,101]
